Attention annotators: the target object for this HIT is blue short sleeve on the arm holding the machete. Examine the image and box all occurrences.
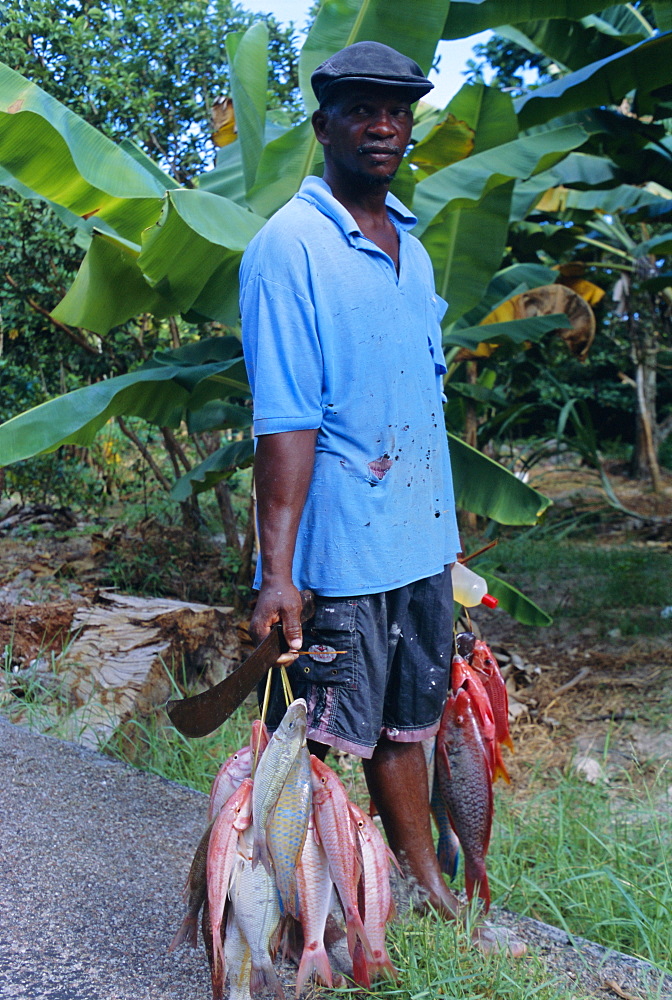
[241,273,323,435]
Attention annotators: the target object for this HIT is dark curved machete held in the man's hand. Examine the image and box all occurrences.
[166,590,315,737]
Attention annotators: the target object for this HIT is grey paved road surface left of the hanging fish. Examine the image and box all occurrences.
[0,718,210,1000]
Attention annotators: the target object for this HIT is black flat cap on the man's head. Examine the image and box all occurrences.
[310,42,434,104]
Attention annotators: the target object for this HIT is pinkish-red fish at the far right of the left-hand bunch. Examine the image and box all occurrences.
[348,802,398,987]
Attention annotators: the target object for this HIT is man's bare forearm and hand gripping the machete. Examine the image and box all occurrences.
[250,429,317,649]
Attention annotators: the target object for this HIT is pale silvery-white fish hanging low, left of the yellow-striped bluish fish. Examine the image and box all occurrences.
[229,828,285,1000]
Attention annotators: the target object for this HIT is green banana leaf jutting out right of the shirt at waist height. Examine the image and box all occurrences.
[448,433,553,524]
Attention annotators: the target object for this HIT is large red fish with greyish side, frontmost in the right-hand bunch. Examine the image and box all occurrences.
[436,687,492,913]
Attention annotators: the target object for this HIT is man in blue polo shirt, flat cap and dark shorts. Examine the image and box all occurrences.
[241,42,516,951]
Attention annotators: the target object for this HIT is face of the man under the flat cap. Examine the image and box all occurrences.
[313,83,413,187]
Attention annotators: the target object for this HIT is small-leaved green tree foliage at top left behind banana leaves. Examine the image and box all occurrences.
[0,0,299,183]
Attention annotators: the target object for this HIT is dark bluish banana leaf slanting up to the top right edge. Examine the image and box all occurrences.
[514,32,672,129]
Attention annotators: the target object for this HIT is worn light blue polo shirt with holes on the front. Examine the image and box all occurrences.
[240,177,460,597]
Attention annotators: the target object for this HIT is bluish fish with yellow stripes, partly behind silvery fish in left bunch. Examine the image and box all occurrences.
[266,746,313,917]
